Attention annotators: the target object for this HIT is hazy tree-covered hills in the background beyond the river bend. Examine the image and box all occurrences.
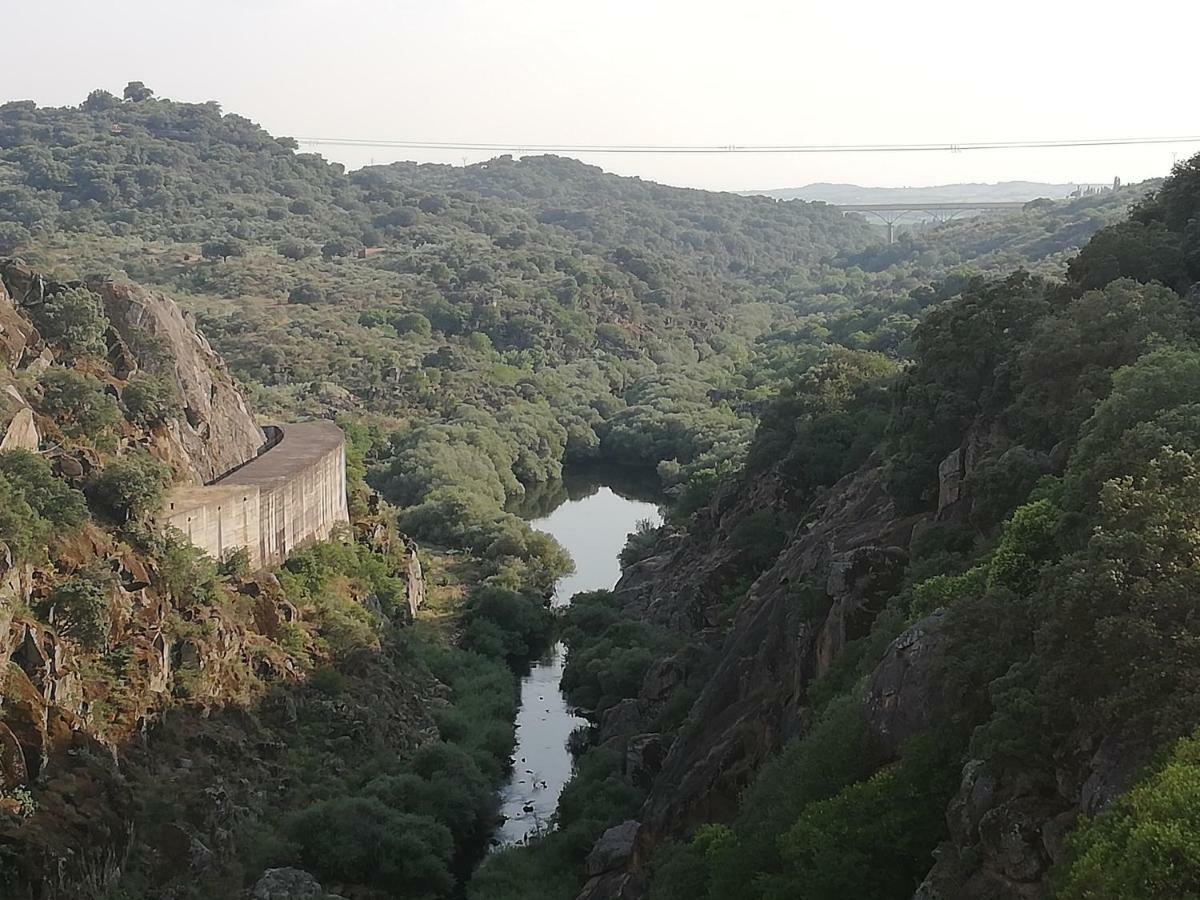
[0,85,1139,619]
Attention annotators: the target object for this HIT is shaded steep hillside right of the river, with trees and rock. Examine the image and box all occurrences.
[472,157,1200,900]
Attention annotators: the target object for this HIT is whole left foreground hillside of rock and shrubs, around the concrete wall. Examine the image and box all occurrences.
[0,259,580,900]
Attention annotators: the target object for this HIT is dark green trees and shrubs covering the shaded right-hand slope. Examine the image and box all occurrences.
[460,160,1200,900]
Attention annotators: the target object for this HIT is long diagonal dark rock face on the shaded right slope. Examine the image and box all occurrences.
[618,469,918,862]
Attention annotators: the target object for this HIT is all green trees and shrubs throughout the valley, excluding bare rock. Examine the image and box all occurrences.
[0,86,1185,900]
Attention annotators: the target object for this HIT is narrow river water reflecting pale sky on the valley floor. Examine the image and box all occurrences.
[496,482,661,846]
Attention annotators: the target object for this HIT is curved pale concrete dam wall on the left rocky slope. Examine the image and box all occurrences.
[160,421,349,569]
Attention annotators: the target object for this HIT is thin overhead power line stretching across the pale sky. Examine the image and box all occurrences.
[288,136,1200,154]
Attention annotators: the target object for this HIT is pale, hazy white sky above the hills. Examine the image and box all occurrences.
[0,0,1200,190]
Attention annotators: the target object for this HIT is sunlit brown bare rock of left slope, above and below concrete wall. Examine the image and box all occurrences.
[0,260,437,900]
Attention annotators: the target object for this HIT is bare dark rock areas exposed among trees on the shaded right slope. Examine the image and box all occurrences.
[580,400,1150,900]
